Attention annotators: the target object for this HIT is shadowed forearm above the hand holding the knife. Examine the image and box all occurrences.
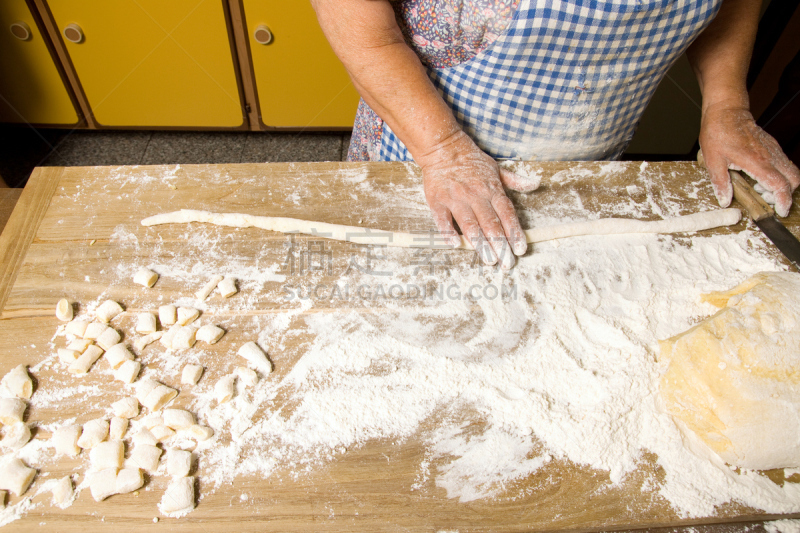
[687,0,761,114]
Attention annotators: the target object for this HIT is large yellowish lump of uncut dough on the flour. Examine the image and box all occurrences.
[659,272,800,470]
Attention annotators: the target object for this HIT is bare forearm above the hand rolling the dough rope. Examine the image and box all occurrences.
[312,0,460,162]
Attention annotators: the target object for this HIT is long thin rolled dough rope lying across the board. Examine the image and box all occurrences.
[142,208,742,250]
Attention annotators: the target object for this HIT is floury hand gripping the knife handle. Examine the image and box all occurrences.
[700,104,800,217]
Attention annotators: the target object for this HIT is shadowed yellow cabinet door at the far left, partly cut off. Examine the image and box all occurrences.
[0,0,78,125]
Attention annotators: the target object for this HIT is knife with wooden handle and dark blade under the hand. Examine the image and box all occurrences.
[728,170,800,270]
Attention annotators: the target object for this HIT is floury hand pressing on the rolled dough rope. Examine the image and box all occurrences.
[417,130,536,269]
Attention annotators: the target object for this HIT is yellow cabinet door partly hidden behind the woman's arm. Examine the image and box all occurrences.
[242,0,358,128]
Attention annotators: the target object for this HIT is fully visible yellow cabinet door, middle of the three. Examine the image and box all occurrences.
[47,0,244,127]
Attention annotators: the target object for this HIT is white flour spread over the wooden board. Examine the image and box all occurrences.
[0,164,800,523]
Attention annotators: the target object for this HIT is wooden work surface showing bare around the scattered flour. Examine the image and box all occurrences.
[0,162,800,533]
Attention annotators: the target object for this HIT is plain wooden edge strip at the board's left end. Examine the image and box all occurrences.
[0,167,64,312]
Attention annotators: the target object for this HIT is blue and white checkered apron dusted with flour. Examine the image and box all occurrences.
[379,0,722,161]
